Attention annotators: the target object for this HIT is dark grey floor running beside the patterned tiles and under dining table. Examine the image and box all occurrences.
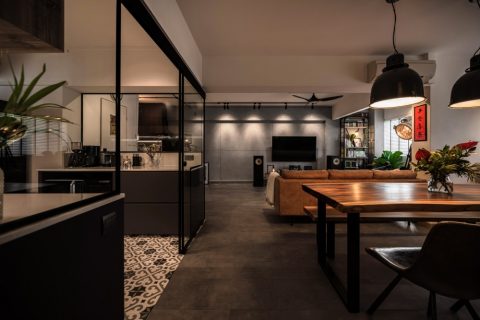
[148,184,480,320]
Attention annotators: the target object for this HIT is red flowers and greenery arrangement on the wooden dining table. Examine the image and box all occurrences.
[412,141,480,193]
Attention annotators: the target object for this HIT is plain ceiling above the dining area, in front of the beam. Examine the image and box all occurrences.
[177,0,480,56]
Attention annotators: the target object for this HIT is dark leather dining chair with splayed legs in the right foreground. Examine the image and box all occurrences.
[366,222,480,319]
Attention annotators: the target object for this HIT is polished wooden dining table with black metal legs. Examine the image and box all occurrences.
[302,182,480,312]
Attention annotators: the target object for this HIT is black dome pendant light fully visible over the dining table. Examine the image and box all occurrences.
[370,0,425,109]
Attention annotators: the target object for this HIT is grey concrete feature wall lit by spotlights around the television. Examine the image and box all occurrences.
[205,106,339,181]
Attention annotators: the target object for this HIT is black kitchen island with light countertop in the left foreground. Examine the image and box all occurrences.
[0,193,124,319]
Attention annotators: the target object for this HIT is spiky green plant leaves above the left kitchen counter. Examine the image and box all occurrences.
[0,62,72,148]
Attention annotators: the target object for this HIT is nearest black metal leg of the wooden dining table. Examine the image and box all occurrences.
[346,212,360,312]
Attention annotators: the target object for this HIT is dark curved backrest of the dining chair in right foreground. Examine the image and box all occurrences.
[405,222,480,300]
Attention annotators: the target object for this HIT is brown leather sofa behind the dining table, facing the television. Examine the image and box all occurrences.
[274,170,424,216]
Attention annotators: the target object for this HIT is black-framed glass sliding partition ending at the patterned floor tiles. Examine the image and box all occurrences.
[119,0,205,253]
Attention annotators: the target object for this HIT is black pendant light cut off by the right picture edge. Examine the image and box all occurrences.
[448,0,480,109]
